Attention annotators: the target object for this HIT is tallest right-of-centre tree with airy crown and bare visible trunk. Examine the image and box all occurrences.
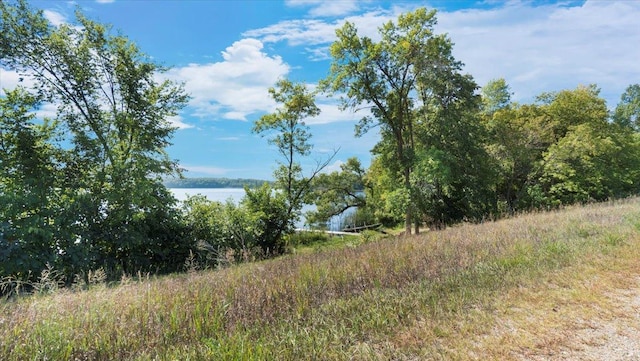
[323,8,496,234]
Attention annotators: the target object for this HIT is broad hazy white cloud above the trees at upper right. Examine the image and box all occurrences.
[438,1,640,106]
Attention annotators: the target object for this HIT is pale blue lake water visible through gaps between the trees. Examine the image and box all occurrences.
[169,188,350,231]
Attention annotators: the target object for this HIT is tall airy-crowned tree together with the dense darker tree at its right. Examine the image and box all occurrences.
[324,8,493,233]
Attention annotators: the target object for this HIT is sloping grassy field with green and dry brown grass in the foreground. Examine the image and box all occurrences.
[0,199,640,360]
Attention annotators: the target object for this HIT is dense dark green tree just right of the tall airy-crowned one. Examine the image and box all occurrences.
[412,70,496,227]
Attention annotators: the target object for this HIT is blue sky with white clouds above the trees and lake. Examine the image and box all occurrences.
[0,0,640,179]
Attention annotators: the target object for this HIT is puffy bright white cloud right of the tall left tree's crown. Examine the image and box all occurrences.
[165,39,289,120]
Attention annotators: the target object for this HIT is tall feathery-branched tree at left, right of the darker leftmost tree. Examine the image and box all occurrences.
[0,0,188,273]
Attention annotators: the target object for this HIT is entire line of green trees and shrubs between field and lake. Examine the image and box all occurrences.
[0,0,640,282]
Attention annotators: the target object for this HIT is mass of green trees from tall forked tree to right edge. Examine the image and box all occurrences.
[314,9,640,233]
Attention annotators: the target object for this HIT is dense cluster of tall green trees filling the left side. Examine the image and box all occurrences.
[0,1,189,280]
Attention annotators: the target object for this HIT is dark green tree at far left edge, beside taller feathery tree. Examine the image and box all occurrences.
[0,88,59,278]
